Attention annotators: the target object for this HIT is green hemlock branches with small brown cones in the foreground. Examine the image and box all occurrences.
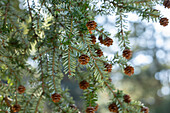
[0,0,167,113]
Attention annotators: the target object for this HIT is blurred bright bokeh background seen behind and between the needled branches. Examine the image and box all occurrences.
[8,0,170,113]
